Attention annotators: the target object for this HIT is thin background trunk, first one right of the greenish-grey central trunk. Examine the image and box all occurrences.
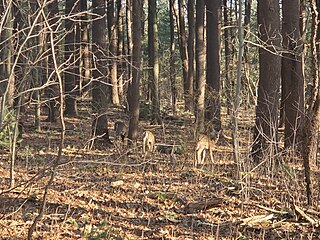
[169,0,177,115]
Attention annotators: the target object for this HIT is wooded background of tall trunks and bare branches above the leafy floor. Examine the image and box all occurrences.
[0,0,320,238]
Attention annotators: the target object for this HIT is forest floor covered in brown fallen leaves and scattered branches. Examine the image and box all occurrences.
[0,101,320,239]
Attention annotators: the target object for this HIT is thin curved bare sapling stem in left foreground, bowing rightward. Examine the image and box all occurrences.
[28,5,66,240]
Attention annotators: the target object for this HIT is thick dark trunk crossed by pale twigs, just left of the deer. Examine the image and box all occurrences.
[92,0,111,143]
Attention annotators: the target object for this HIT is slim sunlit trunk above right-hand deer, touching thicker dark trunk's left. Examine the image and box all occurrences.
[195,0,206,132]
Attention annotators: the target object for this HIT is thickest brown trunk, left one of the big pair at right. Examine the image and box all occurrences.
[252,0,281,163]
